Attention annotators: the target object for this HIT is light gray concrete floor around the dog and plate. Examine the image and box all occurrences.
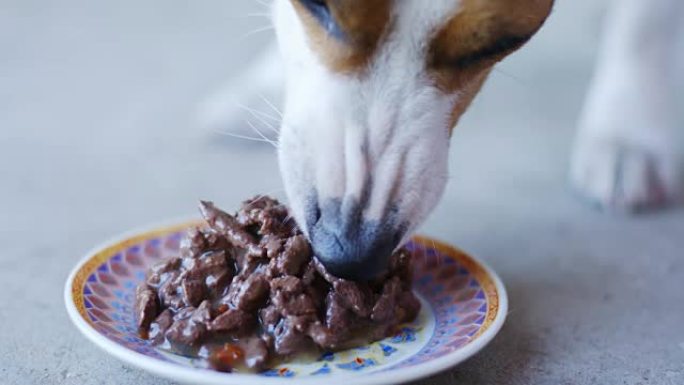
[0,0,684,385]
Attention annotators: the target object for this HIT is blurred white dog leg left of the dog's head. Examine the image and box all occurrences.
[197,43,284,138]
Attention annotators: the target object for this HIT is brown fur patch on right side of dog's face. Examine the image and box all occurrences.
[427,0,553,92]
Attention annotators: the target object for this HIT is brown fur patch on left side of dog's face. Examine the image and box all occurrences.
[291,0,392,73]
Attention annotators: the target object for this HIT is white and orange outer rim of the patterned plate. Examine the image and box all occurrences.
[64,219,508,385]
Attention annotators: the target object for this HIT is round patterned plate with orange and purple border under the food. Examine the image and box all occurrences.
[64,222,508,385]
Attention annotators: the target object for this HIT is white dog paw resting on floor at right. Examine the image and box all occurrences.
[571,139,682,212]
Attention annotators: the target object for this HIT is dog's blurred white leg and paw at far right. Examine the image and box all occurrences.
[571,0,684,211]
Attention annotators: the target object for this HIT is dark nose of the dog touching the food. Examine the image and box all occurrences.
[308,200,403,281]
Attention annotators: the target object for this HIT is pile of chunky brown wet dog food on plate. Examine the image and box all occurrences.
[135,197,420,371]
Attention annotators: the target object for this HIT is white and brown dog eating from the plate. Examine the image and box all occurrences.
[196,0,681,279]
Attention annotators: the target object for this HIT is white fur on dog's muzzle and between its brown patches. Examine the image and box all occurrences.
[274,0,458,238]
